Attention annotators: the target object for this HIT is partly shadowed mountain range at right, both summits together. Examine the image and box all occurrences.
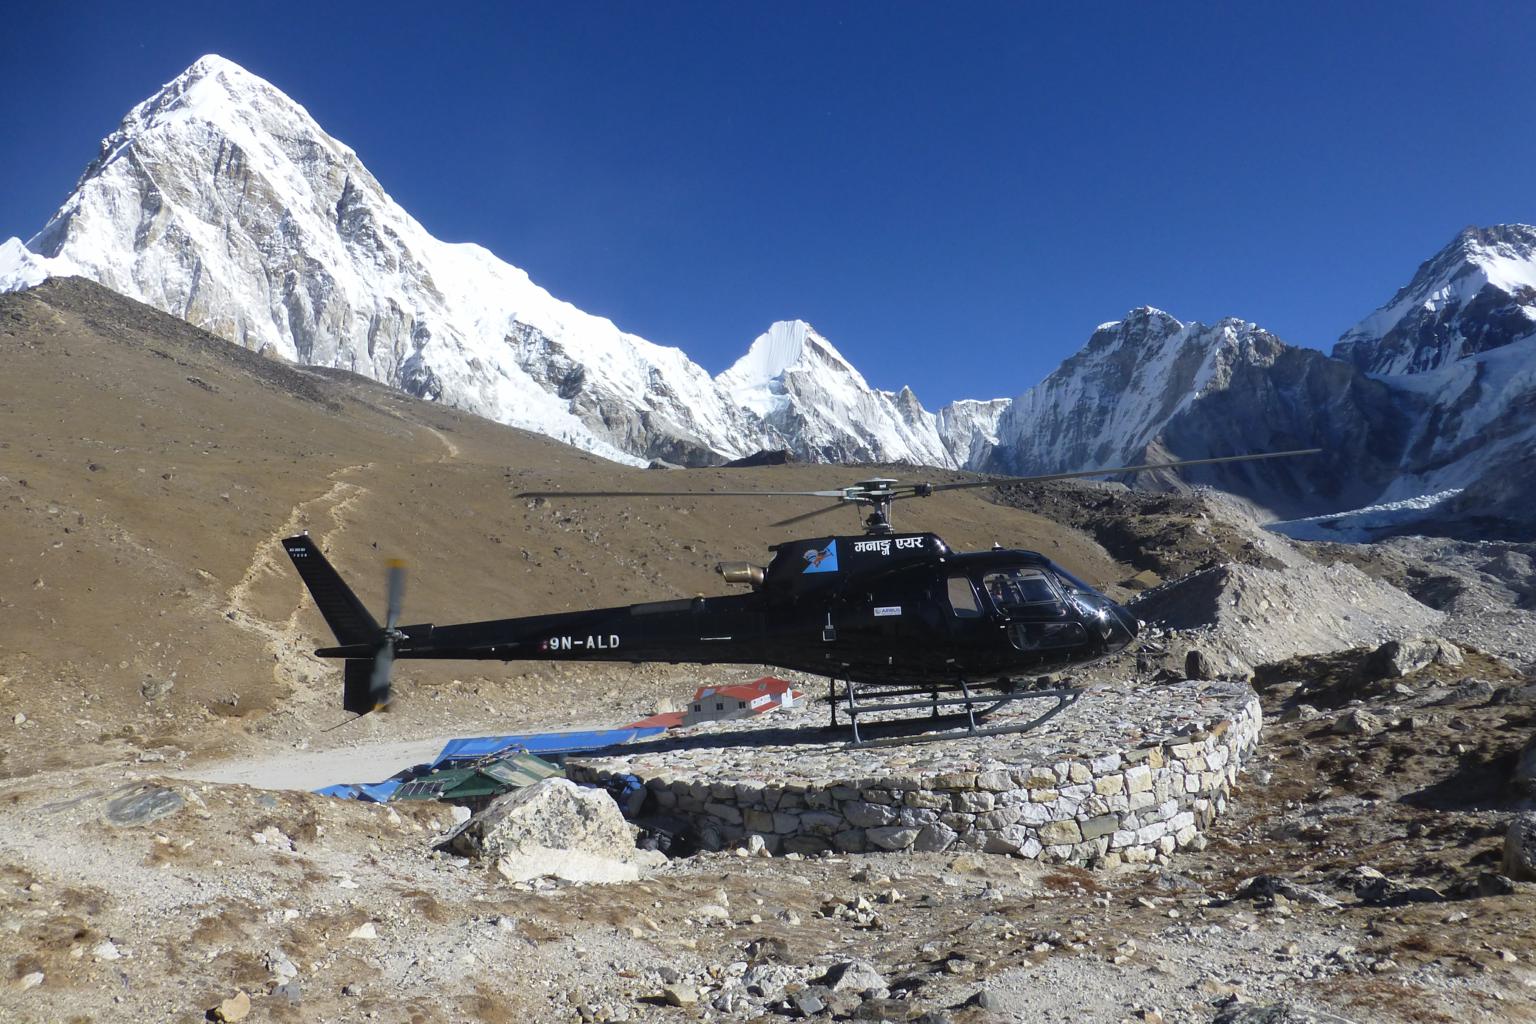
[977,224,1536,537]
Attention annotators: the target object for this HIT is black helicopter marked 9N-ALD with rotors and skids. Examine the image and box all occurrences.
[283,448,1318,743]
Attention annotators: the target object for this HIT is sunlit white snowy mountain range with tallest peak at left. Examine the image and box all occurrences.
[14,54,983,465]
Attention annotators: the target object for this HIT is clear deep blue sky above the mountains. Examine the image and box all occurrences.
[0,0,1536,408]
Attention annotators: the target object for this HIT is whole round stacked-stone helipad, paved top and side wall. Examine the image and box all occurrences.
[568,682,1263,866]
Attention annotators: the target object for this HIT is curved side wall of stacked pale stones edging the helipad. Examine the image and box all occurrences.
[567,691,1263,866]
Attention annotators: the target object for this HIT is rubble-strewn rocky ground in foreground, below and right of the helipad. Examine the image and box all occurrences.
[0,491,1536,1024]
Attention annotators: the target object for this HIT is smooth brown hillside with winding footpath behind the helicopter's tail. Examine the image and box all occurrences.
[0,278,1127,774]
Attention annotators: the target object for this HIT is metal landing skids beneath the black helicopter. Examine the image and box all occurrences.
[826,679,1083,748]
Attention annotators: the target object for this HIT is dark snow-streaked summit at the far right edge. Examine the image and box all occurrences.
[1333,224,1536,376]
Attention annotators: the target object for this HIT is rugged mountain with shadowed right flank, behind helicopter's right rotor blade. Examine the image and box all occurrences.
[983,309,1410,514]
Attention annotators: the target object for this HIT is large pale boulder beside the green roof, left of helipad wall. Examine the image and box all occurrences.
[452,778,665,881]
